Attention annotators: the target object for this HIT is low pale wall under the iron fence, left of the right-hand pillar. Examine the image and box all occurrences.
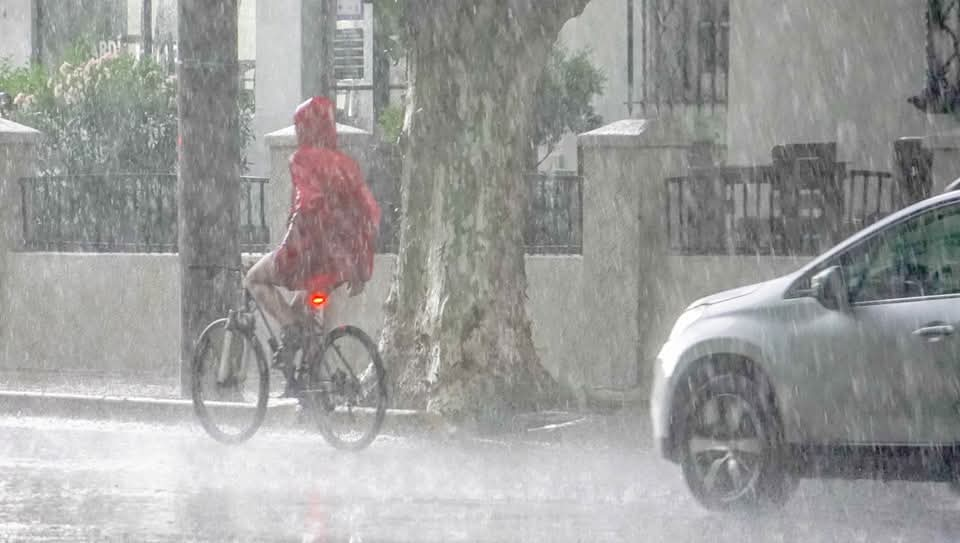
[0,253,583,388]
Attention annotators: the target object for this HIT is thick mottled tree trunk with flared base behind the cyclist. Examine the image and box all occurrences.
[382,0,586,428]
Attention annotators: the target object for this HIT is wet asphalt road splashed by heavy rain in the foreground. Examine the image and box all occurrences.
[0,418,960,543]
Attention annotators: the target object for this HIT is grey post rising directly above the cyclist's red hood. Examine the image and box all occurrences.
[300,0,337,101]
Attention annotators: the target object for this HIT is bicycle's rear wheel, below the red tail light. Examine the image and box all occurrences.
[303,326,387,451]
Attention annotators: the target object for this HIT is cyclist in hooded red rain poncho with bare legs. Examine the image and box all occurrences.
[245,97,380,376]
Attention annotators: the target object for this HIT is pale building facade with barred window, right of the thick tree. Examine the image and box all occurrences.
[555,0,960,174]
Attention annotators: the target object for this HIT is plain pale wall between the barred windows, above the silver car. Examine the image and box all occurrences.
[727,0,956,170]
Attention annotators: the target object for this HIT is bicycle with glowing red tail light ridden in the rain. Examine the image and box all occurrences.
[191,270,387,450]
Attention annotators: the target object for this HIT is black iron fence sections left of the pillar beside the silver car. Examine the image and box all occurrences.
[20,168,583,254]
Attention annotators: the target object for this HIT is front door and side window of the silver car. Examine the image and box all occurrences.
[787,205,960,443]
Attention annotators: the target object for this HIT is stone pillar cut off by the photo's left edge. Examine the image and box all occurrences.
[0,119,40,340]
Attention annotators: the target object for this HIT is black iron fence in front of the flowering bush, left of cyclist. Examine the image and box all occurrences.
[20,174,270,252]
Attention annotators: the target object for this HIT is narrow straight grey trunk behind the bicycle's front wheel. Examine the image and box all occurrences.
[177,0,240,395]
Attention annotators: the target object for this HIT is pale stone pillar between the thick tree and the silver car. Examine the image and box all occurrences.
[571,119,693,397]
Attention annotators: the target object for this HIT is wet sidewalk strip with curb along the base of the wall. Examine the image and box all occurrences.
[0,370,649,448]
